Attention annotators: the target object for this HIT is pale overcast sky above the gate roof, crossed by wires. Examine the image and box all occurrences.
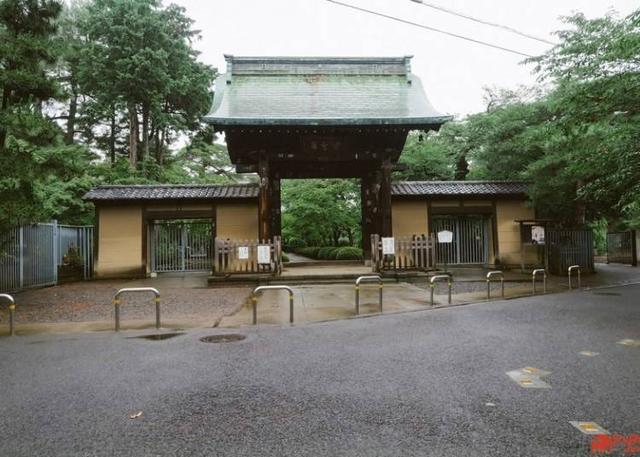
[173,0,638,115]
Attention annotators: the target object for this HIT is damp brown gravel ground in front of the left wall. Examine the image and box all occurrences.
[0,273,251,335]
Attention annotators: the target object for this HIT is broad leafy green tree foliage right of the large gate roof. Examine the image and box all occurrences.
[410,10,640,232]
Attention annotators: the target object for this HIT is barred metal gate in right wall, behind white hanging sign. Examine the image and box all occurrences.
[432,215,489,265]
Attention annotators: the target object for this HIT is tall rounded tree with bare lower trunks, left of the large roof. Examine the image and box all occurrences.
[80,0,215,168]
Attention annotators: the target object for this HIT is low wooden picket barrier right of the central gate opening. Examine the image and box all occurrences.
[371,235,436,272]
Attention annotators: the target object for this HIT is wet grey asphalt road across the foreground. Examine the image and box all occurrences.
[0,286,640,457]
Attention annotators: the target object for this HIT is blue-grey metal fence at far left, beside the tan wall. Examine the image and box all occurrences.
[0,222,93,291]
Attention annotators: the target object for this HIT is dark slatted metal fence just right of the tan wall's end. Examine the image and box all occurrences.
[546,230,594,275]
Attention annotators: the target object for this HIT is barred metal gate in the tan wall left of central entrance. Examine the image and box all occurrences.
[150,219,213,273]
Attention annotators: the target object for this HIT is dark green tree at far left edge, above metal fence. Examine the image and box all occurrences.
[0,0,91,231]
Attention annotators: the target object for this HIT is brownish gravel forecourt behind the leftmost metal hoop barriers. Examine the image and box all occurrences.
[0,281,251,325]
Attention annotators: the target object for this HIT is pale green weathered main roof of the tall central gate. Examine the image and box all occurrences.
[205,56,451,127]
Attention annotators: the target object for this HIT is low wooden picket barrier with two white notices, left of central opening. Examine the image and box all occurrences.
[213,236,282,275]
